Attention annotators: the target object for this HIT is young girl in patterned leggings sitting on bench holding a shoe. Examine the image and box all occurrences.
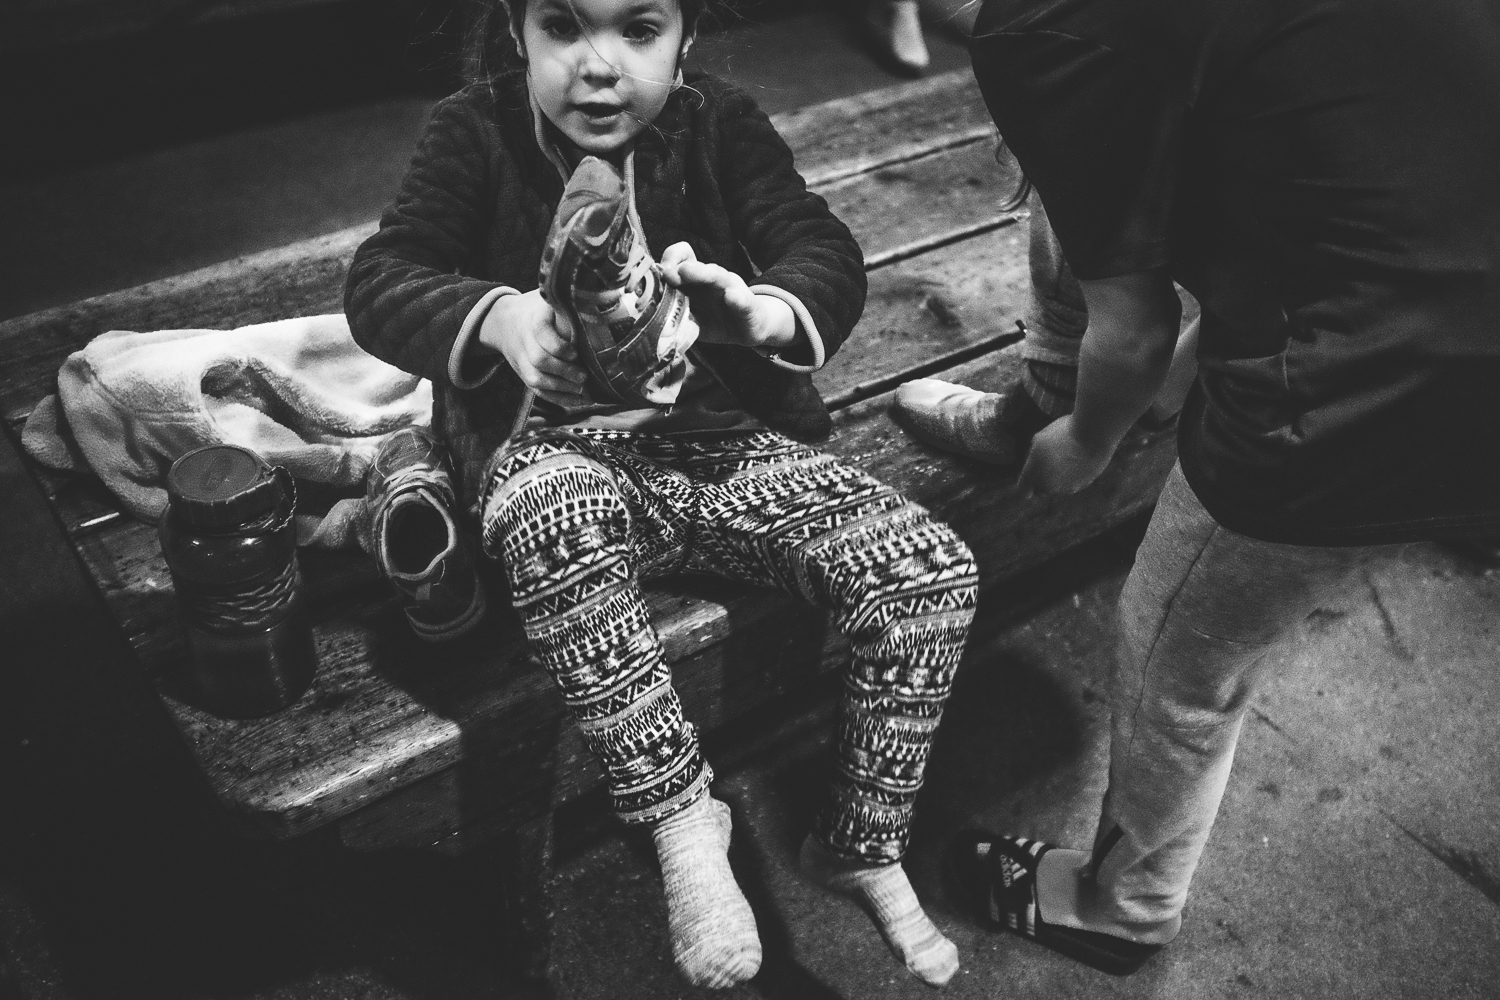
[347,0,977,987]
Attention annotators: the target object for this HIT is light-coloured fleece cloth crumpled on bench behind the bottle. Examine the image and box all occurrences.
[21,313,432,547]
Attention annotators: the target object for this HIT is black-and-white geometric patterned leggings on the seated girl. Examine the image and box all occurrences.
[483,427,977,864]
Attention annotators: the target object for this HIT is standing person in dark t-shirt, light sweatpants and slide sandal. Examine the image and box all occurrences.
[912,0,1500,973]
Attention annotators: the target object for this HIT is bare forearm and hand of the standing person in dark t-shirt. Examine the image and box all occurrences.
[1020,268,1182,493]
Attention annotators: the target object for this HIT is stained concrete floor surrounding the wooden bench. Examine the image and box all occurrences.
[0,0,1500,1000]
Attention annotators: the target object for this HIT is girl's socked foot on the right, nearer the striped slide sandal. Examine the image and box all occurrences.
[801,834,959,987]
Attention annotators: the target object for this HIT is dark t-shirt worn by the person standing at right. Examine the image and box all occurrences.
[971,0,1500,544]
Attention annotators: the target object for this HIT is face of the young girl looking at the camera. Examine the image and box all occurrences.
[522,0,693,156]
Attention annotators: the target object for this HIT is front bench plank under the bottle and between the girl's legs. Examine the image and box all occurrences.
[165,582,834,841]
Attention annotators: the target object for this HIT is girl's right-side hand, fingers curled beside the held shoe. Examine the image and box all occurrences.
[662,243,797,348]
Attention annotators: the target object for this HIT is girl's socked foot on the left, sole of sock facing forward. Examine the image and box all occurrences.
[651,795,761,988]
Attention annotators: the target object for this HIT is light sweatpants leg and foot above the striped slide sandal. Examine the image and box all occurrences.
[1038,466,1373,943]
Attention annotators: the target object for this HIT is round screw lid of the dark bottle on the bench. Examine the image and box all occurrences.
[167,444,285,531]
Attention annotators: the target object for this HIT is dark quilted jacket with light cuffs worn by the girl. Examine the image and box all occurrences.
[344,73,866,507]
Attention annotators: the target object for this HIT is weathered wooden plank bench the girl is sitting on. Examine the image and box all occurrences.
[0,73,1173,975]
